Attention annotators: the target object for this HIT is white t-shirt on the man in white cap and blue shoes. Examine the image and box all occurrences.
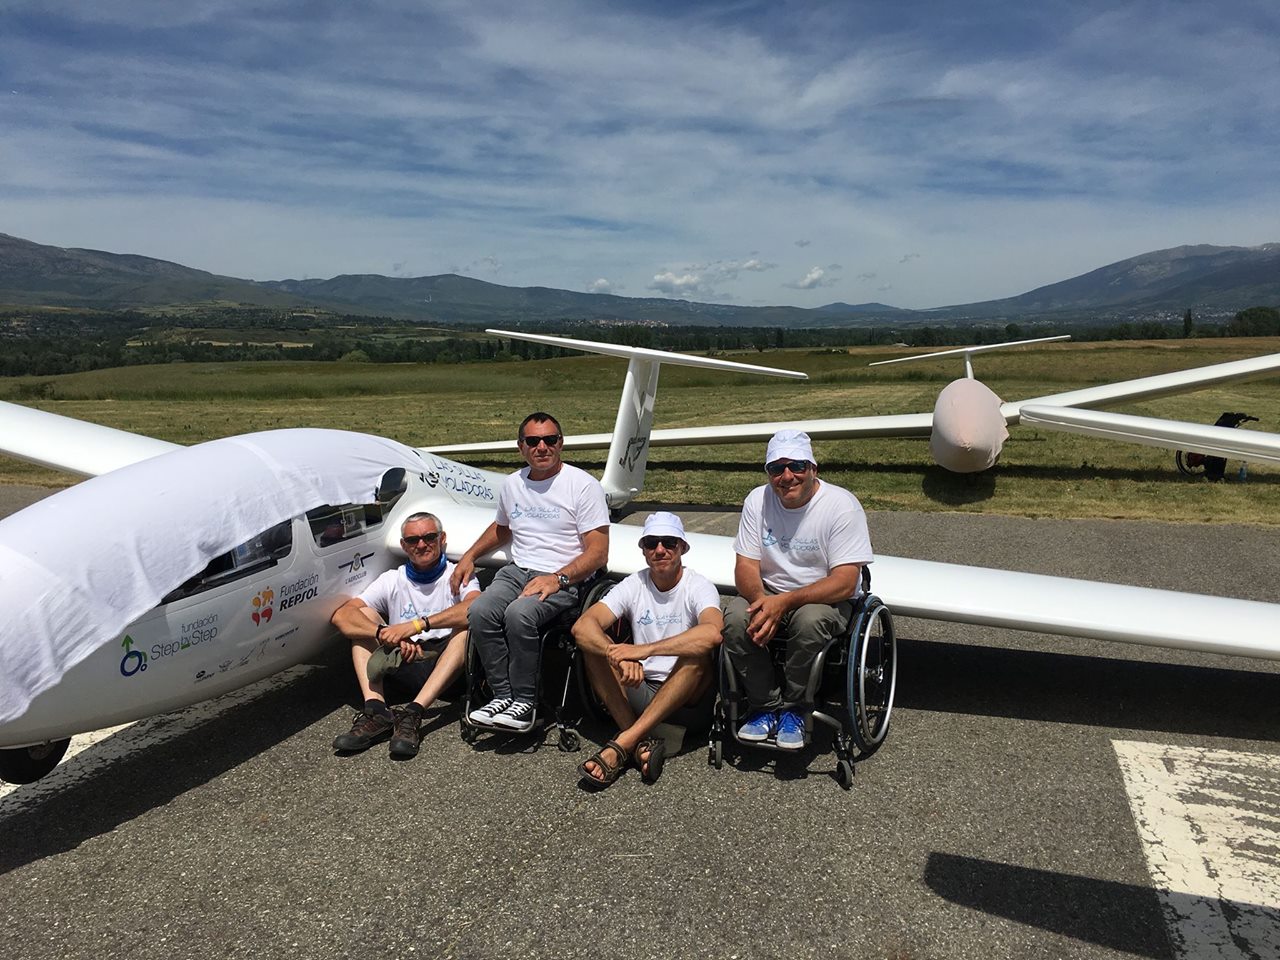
[733,481,876,596]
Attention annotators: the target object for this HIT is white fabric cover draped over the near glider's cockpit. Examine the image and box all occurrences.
[0,429,422,723]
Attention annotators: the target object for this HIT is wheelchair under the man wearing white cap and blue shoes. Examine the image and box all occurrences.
[707,576,897,790]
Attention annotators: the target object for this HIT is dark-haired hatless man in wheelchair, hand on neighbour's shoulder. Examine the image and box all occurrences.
[453,411,609,731]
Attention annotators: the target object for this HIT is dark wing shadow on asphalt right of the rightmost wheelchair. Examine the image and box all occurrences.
[896,637,1280,741]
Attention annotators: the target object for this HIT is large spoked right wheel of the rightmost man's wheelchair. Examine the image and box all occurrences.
[846,596,897,756]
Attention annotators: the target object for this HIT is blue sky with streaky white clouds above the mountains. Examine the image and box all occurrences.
[0,0,1280,307]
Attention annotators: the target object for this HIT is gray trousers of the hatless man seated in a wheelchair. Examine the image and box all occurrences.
[467,563,579,703]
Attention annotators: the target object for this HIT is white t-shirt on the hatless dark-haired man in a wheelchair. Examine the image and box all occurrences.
[497,463,609,572]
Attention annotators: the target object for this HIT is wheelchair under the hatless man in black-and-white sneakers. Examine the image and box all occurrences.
[458,573,614,753]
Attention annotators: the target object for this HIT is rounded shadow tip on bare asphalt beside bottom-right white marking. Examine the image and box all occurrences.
[924,852,1172,959]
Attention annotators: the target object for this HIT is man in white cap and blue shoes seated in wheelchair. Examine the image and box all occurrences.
[724,430,874,750]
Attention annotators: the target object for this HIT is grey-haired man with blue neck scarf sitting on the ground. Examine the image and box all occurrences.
[332,513,480,759]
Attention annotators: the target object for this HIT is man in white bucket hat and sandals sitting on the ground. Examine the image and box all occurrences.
[573,512,724,787]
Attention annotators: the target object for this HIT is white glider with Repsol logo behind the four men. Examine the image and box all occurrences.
[0,335,1280,781]
